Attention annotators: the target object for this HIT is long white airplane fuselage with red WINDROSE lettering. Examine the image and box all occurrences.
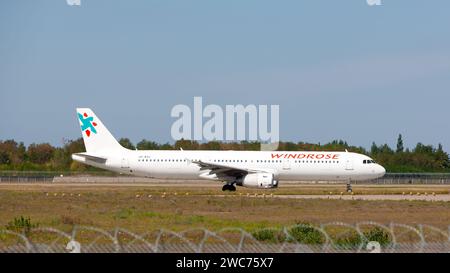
[73,149,385,181]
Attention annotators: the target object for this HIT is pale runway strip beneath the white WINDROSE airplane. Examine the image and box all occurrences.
[0,180,450,202]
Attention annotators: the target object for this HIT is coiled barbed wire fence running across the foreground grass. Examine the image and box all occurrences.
[0,221,450,253]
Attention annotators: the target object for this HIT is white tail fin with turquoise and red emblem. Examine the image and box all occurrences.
[77,108,125,154]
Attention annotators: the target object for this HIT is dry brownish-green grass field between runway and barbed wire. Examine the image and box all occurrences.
[0,184,450,235]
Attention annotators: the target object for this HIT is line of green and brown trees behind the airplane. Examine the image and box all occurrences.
[0,135,450,172]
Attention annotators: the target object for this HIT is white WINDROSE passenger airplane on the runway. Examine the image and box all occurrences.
[72,108,386,191]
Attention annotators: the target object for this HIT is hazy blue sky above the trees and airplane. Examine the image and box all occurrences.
[0,0,450,151]
